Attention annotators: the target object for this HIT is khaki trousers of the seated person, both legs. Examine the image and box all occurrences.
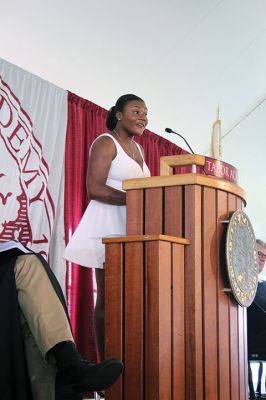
[15,254,74,400]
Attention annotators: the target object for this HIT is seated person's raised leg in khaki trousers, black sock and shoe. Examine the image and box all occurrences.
[15,255,123,398]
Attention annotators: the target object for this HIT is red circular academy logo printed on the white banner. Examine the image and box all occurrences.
[0,77,54,255]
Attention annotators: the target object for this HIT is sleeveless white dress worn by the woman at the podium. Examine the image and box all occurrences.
[63,133,150,268]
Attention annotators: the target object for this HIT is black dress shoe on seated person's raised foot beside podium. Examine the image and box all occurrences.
[55,358,123,393]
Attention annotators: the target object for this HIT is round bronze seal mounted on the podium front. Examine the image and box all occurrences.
[226,210,258,307]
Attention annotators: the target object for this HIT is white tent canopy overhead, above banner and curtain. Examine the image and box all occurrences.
[0,0,266,240]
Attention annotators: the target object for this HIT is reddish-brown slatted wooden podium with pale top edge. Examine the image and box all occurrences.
[104,156,248,400]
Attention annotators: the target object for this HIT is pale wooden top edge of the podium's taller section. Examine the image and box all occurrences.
[123,174,246,202]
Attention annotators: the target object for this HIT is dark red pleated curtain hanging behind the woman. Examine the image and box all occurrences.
[65,92,186,361]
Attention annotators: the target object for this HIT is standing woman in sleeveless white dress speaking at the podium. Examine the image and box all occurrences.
[64,94,150,360]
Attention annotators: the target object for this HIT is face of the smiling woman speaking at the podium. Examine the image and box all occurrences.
[116,100,148,136]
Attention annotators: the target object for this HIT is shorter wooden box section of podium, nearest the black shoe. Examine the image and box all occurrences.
[104,235,188,400]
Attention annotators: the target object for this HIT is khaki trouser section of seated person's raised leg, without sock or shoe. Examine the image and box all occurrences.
[15,254,74,357]
